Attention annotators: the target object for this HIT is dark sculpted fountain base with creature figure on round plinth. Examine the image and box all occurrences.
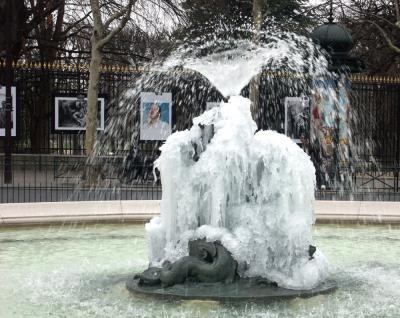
[126,239,336,301]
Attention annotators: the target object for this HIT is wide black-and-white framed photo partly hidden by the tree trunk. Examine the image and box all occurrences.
[54,96,105,132]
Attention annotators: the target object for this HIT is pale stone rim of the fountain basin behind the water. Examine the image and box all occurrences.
[0,200,400,226]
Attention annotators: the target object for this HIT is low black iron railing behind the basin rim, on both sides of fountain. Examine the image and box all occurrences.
[0,154,400,203]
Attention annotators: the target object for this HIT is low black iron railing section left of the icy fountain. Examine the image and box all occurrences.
[0,154,161,203]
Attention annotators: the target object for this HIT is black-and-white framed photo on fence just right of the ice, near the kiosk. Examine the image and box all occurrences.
[285,97,310,143]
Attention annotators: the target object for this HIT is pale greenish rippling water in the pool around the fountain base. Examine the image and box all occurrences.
[0,224,400,318]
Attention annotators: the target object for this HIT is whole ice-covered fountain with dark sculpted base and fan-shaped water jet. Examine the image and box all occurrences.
[127,31,336,299]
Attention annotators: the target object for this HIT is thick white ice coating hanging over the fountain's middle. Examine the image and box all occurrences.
[146,96,328,289]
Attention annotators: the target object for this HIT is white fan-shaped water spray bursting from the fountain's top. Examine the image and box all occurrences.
[160,32,328,97]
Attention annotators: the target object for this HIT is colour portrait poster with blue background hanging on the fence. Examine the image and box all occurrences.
[140,92,172,140]
